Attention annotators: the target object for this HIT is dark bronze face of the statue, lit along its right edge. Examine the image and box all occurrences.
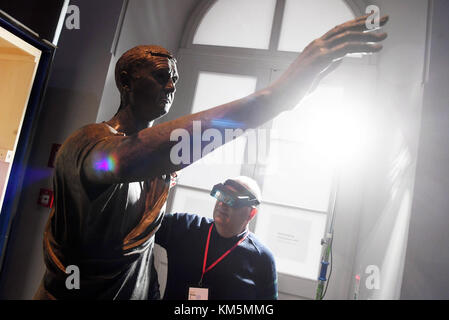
[130,57,178,121]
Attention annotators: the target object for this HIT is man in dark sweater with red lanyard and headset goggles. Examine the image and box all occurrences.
[156,177,277,300]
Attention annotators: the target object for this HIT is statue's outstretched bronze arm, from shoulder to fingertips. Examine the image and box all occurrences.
[83,16,388,184]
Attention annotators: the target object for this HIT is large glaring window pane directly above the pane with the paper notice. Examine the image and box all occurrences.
[262,86,344,211]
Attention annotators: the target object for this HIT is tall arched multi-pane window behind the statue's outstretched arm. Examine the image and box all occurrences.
[165,0,376,298]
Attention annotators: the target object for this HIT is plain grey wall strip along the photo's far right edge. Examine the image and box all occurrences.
[401,0,449,299]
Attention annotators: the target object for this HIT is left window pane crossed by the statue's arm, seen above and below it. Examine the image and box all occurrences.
[179,72,257,190]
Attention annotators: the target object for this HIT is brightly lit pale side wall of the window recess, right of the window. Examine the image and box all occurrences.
[339,0,427,299]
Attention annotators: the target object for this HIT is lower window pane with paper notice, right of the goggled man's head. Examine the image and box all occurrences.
[256,203,326,280]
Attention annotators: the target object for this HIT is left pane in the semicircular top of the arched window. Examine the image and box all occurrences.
[193,0,276,49]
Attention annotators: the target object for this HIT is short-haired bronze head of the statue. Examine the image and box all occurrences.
[115,45,178,121]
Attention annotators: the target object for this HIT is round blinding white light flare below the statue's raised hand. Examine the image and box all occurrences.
[277,86,375,166]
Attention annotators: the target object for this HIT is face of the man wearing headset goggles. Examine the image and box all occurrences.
[214,186,252,238]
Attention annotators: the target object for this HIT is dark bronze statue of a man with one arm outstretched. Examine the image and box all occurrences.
[35,16,387,299]
